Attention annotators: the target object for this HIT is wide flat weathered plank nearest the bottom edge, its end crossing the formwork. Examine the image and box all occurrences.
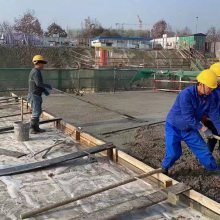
[74,183,190,220]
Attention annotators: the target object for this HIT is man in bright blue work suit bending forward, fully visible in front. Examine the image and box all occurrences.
[162,70,220,175]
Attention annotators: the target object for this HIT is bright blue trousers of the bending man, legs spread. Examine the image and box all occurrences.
[162,122,218,170]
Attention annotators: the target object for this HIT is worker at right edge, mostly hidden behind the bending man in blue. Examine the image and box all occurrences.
[202,63,220,154]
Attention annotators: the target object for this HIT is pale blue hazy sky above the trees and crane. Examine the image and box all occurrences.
[0,0,220,33]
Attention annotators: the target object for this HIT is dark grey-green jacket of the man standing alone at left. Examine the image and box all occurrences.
[28,68,48,96]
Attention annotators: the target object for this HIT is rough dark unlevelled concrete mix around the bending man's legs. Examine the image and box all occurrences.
[130,125,220,202]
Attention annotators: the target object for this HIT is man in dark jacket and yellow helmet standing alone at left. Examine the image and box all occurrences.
[28,55,52,134]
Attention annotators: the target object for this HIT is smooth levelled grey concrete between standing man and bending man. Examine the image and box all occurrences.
[43,91,176,151]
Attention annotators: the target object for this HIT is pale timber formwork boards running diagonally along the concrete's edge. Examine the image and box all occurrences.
[12,94,220,219]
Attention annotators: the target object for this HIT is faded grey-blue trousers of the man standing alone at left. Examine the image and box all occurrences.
[28,93,42,119]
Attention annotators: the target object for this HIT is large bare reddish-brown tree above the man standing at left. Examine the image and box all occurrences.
[14,10,43,36]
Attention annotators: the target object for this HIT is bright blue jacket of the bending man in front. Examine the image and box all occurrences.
[166,85,220,133]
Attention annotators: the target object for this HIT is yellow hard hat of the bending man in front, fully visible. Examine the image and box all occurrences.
[196,69,217,89]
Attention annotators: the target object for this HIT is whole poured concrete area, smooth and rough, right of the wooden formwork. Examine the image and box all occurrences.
[41,91,220,205]
